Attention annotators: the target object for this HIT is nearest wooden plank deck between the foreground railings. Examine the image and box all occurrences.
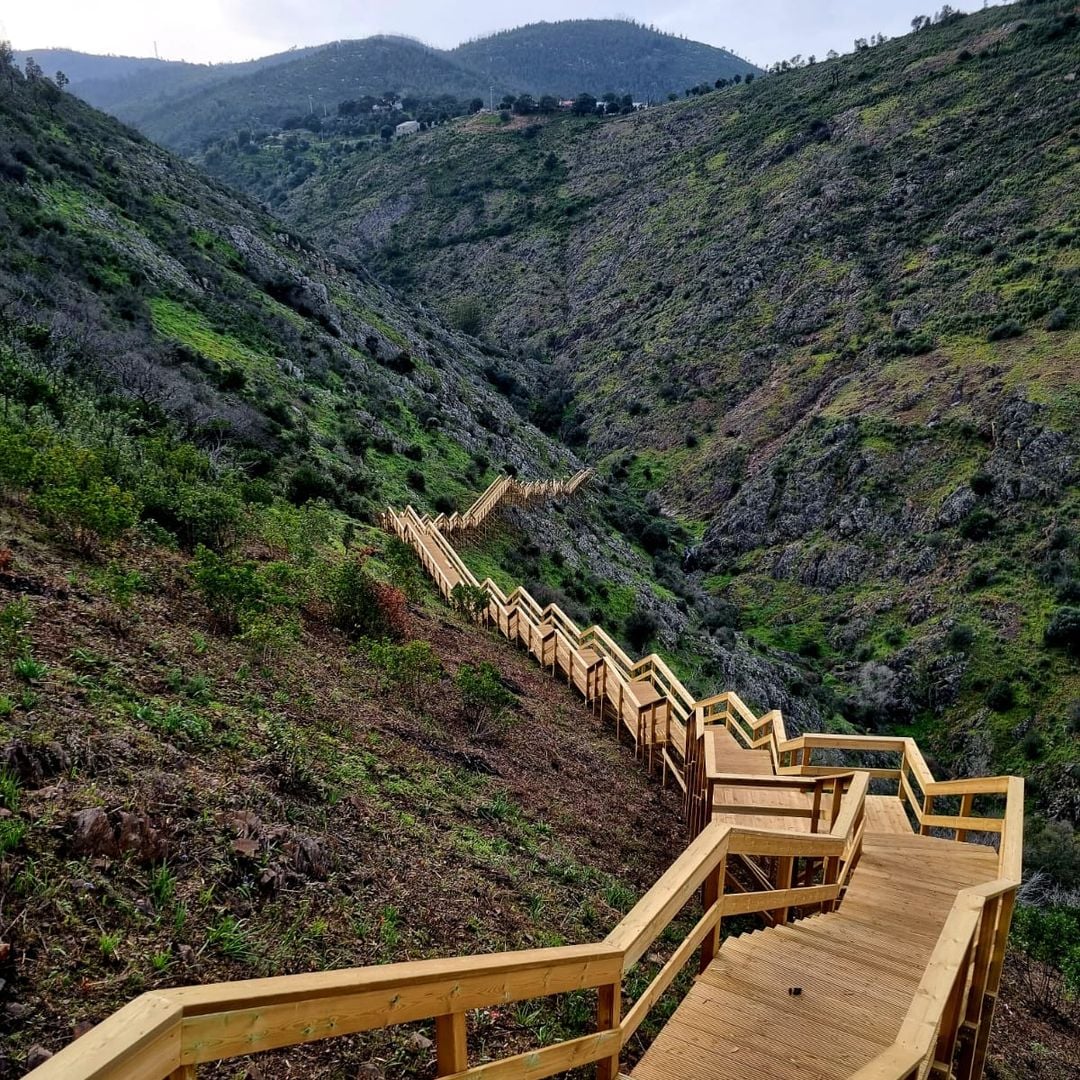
[631,829,998,1080]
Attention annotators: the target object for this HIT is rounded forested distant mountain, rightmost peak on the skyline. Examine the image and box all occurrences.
[450,18,758,100]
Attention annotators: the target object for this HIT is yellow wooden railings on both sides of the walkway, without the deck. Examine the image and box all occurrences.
[25,473,1024,1080]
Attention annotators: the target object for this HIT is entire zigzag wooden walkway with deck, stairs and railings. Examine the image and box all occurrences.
[31,471,1024,1080]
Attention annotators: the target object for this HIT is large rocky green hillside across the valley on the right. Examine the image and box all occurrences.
[285,2,1080,803]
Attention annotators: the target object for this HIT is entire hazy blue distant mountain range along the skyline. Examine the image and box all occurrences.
[17,19,757,154]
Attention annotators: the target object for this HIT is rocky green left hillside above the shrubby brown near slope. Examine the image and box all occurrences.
[0,59,587,518]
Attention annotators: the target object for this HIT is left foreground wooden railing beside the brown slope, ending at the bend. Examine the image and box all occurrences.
[31,813,876,1080]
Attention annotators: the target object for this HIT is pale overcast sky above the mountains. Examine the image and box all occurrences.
[0,0,1006,65]
